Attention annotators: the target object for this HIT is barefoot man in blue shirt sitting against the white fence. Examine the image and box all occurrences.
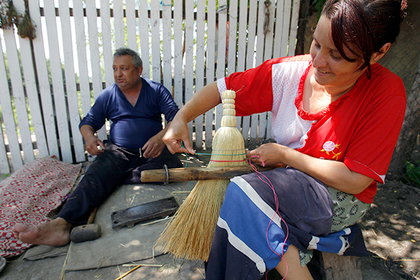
[12,48,182,246]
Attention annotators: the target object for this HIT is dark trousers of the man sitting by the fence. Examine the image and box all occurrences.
[58,141,182,225]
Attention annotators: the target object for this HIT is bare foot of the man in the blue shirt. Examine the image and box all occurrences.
[12,218,71,246]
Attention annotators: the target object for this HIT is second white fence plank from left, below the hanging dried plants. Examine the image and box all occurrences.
[4,29,34,163]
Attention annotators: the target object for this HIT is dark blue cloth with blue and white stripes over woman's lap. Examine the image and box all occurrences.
[206,168,367,280]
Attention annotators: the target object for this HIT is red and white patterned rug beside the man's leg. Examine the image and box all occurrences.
[0,156,81,257]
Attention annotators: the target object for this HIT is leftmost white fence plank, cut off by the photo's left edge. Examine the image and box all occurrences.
[0,33,23,173]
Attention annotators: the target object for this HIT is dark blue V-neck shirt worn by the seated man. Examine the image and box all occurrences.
[79,78,178,149]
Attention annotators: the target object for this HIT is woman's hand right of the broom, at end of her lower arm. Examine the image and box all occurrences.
[246,143,284,167]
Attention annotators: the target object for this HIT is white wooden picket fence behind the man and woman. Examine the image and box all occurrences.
[0,0,300,173]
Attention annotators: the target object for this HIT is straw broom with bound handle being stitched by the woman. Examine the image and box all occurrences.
[155,90,247,261]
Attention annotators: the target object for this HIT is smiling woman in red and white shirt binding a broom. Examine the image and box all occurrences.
[164,0,406,280]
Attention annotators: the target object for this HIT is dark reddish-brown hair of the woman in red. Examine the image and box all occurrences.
[321,0,407,77]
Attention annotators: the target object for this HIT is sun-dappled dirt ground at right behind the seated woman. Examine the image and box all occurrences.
[360,181,420,279]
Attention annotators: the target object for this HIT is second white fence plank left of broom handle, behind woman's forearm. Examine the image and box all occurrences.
[194,0,206,149]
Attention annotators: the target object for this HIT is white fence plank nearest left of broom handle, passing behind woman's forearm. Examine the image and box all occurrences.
[205,0,216,148]
